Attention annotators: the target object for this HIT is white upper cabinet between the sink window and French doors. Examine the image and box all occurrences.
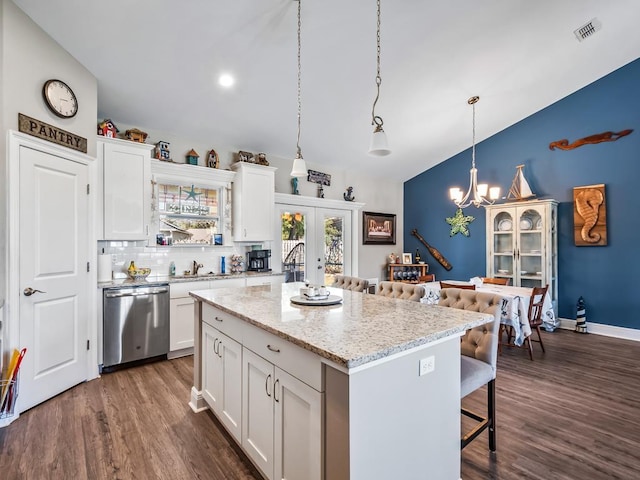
[231,162,276,242]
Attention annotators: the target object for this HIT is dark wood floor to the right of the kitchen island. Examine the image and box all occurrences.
[462,330,640,480]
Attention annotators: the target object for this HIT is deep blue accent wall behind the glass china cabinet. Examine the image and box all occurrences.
[404,55,640,329]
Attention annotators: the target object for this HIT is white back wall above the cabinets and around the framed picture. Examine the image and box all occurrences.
[110,122,404,280]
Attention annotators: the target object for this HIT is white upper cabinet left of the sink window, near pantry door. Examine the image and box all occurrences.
[97,137,153,240]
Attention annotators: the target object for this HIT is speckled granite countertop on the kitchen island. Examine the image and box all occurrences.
[189,283,494,369]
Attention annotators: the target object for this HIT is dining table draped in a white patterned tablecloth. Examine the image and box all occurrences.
[419,280,558,346]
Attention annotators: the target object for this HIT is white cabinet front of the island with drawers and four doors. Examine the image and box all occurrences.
[201,304,324,480]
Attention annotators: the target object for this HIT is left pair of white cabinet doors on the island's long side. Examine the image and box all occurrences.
[202,323,242,442]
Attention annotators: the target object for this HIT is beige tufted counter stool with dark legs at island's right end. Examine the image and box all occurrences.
[438,288,503,452]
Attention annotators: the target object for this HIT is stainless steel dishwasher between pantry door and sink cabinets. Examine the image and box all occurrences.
[102,284,169,372]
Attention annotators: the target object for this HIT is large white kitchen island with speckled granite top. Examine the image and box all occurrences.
[190,283,493,480]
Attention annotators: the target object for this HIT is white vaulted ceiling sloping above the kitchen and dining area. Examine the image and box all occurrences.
[14,0,640,180]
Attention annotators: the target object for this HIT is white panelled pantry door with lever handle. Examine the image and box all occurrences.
[17,146,91,411]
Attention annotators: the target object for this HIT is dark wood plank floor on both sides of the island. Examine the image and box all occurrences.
[0,331,640,480]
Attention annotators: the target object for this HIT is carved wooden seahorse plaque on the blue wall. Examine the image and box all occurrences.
[573,184,607,246]
